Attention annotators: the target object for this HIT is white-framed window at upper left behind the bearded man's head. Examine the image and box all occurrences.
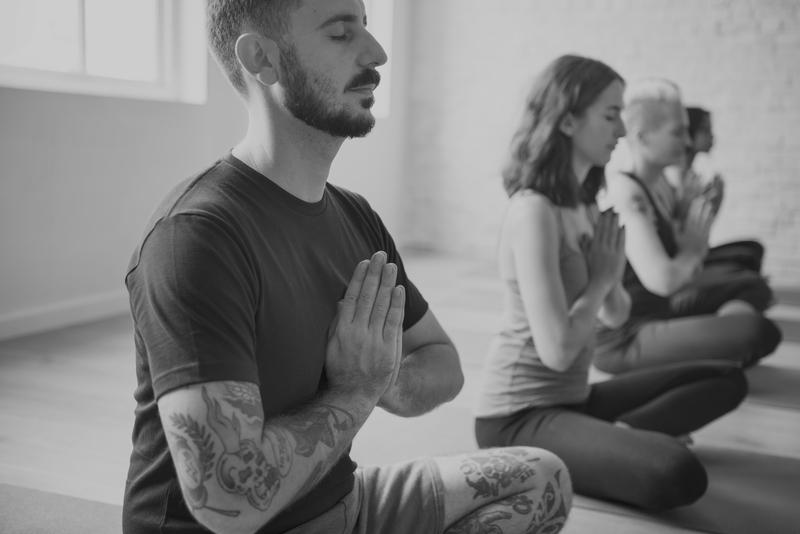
[0,0,206,103]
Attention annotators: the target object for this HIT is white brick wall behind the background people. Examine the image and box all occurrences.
[401,0,800,286]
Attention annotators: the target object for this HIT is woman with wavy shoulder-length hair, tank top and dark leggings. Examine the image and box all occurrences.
[475,55,747,510]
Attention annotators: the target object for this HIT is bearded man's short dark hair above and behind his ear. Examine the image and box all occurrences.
[206,0,302,93]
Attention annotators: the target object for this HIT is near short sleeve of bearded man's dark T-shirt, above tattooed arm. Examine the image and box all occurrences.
[127,214,258,398]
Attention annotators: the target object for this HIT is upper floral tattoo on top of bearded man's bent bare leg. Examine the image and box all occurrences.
[461,450,539,499]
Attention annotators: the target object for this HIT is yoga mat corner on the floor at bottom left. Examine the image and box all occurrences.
[0,484,122,534]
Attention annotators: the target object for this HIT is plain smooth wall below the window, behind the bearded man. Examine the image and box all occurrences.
[0,2,408,339]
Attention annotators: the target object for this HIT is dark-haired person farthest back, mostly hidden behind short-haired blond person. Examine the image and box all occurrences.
[664,106,764,273]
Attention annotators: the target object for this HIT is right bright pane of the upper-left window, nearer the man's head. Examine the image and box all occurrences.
[86,0,161,82]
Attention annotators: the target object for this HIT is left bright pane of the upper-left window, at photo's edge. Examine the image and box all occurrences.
[0,0,81,72]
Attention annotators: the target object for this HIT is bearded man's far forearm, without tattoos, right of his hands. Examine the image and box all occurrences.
[378,343,464,417]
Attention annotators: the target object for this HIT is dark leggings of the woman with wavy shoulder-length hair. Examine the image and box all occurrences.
[475,362,747,510]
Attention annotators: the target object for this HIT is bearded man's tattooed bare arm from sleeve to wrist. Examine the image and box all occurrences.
[168,383,377,533]
